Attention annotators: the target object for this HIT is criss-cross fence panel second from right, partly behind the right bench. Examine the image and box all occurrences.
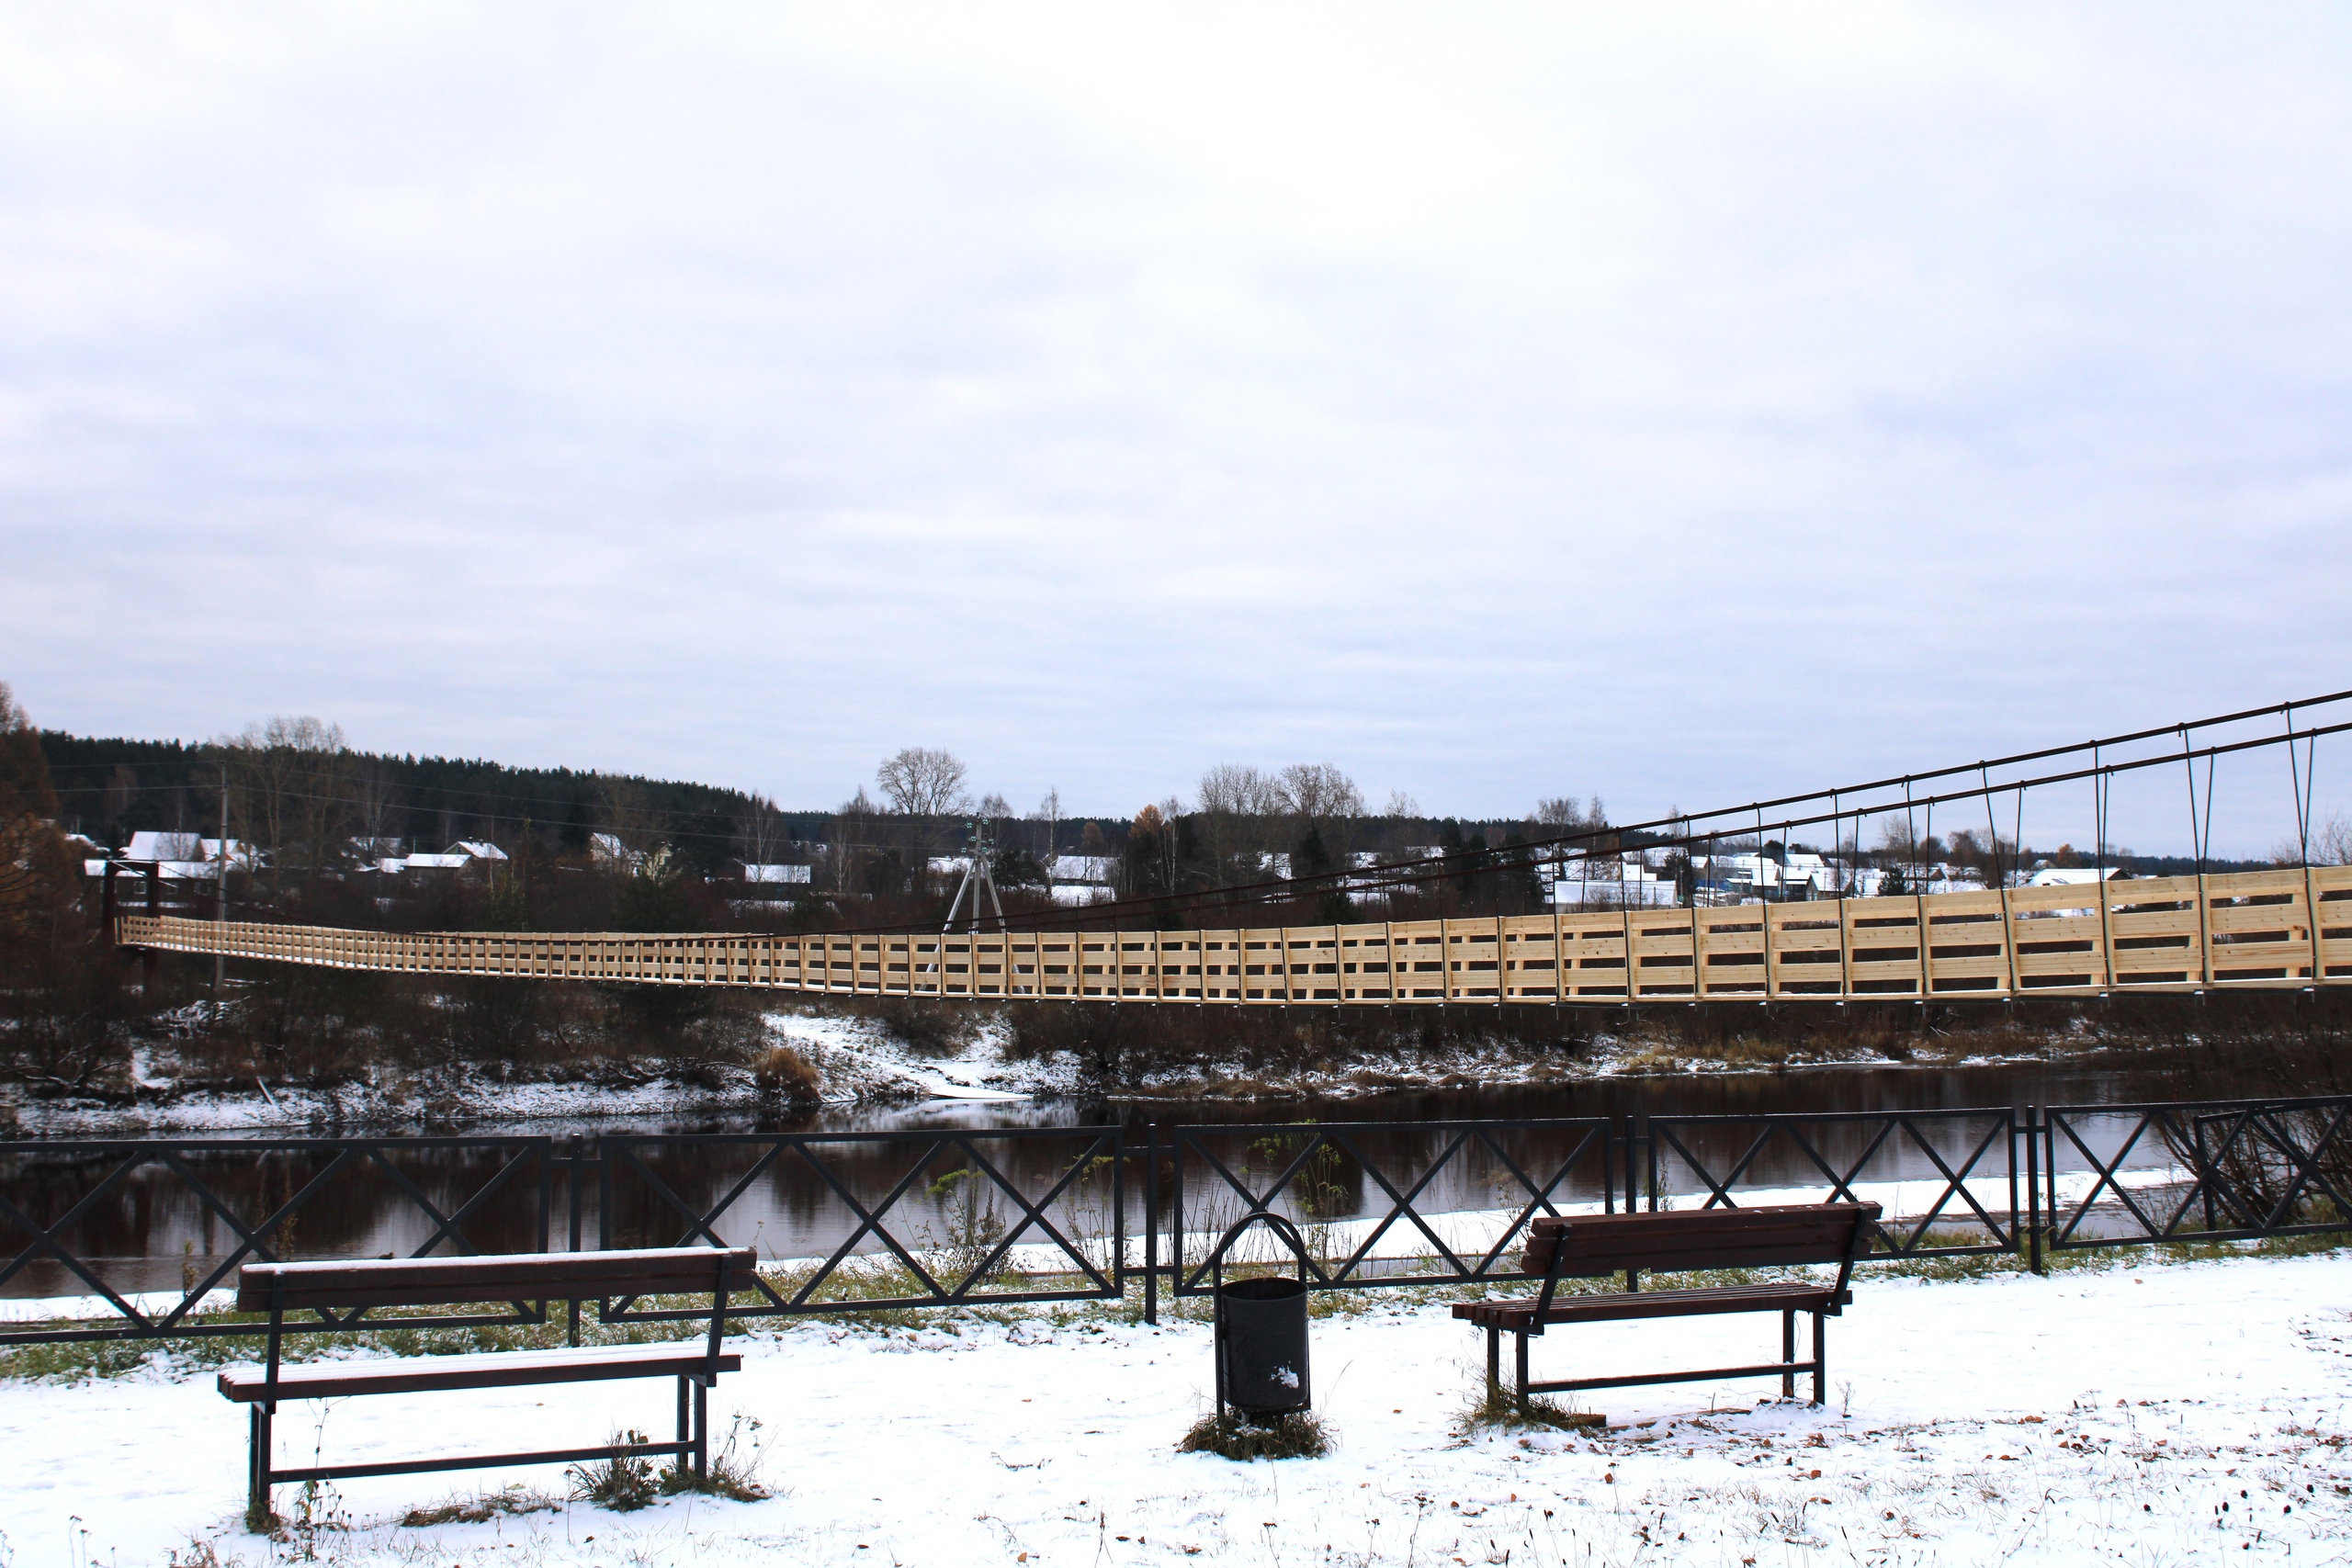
[1628,1110,2034,1258]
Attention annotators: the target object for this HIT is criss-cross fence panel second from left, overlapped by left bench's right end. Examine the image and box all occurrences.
[597,1126,1126,1321]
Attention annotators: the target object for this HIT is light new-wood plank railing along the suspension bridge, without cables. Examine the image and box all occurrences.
[118,865,2352,1006]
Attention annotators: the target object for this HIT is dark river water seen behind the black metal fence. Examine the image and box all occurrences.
[0,1063,2257,1298]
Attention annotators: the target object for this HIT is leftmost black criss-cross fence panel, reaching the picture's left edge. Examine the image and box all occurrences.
[0,1138,553,1345]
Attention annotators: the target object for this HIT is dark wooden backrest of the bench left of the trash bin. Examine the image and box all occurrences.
[238,1246,757,1312]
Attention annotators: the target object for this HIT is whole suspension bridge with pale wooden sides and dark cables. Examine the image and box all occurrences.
[115,691,2352,1006]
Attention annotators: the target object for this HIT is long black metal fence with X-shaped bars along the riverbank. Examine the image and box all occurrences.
[14,1096,2352,1345]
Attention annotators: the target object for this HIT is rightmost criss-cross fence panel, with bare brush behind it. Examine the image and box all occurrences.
[2040,1096,2352,1248]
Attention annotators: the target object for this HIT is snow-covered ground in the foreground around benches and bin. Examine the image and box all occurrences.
[0,1256,2352,1568]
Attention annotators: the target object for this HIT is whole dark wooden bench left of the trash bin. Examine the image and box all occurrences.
[221,1246,752,1518]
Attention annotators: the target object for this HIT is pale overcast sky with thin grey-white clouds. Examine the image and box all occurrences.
[0,5,2352,849]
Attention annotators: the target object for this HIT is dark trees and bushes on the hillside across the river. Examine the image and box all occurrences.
[0,684,2352,1093]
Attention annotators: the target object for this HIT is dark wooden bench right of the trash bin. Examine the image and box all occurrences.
[1453,1203,1879,1411]
